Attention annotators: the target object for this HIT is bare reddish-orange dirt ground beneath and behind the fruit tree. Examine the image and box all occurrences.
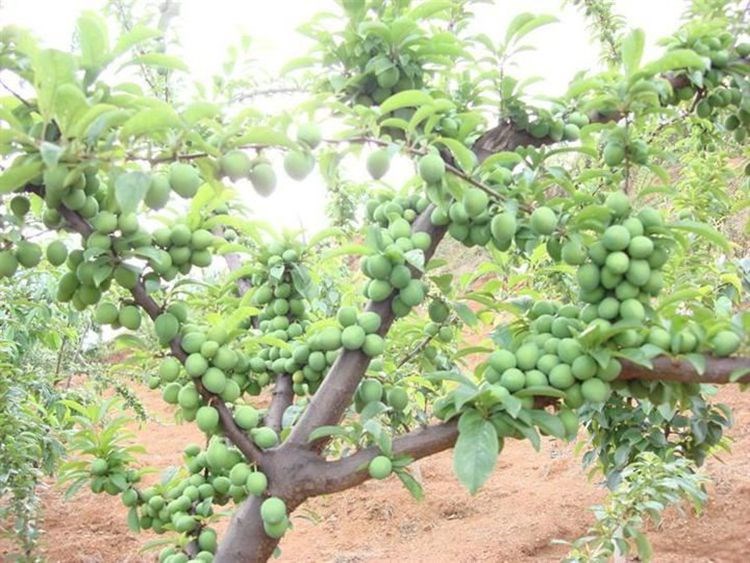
[0,382,750,563]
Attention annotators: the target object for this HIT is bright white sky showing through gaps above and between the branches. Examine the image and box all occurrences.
[0,0,688,232]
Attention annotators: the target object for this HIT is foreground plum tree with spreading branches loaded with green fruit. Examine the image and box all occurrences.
[0,0,750,563]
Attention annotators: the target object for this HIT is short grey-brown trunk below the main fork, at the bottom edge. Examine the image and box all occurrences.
[214,496,293,563]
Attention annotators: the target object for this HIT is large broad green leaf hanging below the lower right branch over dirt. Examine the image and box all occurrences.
[453,410,499,494]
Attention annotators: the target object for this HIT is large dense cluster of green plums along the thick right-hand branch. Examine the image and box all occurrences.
[483,192,740,408]
